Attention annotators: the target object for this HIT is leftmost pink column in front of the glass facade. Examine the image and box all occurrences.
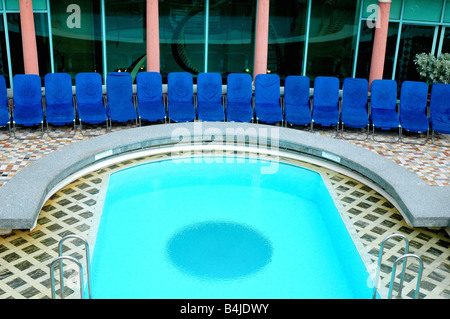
[19,0,39,75]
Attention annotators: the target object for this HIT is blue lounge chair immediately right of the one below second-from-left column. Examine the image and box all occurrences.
[167,72,195,122]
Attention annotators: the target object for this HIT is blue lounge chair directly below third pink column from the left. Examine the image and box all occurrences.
[255,74,283,124]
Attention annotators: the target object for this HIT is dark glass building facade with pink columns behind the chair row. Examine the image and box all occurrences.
[0,0,450,87]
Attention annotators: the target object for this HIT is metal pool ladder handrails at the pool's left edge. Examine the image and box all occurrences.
[50,234,91,299]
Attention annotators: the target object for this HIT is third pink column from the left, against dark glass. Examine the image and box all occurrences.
[253,0,270,79]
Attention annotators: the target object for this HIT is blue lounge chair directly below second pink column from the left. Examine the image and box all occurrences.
[136,72,167,125]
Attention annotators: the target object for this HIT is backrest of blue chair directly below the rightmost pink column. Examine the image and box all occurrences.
[370,80,397,110]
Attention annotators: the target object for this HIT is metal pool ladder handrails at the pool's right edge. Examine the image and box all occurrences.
[373,234,423,299]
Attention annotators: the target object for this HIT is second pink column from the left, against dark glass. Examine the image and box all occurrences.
[147,0,160,72]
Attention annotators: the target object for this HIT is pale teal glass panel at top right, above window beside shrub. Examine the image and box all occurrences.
[403,0,444,22]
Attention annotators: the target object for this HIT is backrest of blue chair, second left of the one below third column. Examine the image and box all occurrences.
[197,72,222,105]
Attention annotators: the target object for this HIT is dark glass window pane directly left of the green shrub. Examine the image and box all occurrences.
[396,24,435,86]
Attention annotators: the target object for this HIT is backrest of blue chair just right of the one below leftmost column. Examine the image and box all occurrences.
[44,73,73,108]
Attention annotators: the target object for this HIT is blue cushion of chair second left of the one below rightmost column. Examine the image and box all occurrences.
[312,76,339,126]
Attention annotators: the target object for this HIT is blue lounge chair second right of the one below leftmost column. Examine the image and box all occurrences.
[75,72,108,135]
